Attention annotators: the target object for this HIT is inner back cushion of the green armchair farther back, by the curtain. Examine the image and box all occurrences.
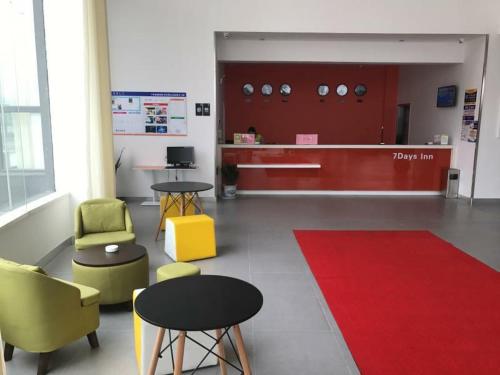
[81,201,125,234]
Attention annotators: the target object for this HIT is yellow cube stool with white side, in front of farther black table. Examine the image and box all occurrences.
[165,215,217,262]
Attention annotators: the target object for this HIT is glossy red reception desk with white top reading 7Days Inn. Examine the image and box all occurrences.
[219,144,453,194]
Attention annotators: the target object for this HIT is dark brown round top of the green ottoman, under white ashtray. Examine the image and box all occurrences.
[73,243,147,267]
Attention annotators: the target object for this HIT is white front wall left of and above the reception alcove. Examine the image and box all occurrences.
[107,0,500,196]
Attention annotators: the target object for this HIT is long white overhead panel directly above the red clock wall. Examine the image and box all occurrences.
[217,35,465,64]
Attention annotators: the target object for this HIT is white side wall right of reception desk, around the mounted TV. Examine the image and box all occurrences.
[398,37,485,197]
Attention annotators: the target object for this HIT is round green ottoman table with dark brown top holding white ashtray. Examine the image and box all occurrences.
[72,244,149,305]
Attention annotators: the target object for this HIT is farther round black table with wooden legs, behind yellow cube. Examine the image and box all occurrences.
[151,181,214,239]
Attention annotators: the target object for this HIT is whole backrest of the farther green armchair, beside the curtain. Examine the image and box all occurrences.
[75,198,126,235]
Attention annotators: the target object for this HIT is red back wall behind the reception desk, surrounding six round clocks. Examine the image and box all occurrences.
[224,63,399,144]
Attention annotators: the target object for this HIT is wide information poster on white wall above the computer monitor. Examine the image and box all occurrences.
[111,91,187,135]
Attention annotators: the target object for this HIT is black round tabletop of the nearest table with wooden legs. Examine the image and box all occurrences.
[135,275,264,331]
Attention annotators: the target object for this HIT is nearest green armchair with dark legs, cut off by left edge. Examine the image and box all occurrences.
[0,258,100,375]
